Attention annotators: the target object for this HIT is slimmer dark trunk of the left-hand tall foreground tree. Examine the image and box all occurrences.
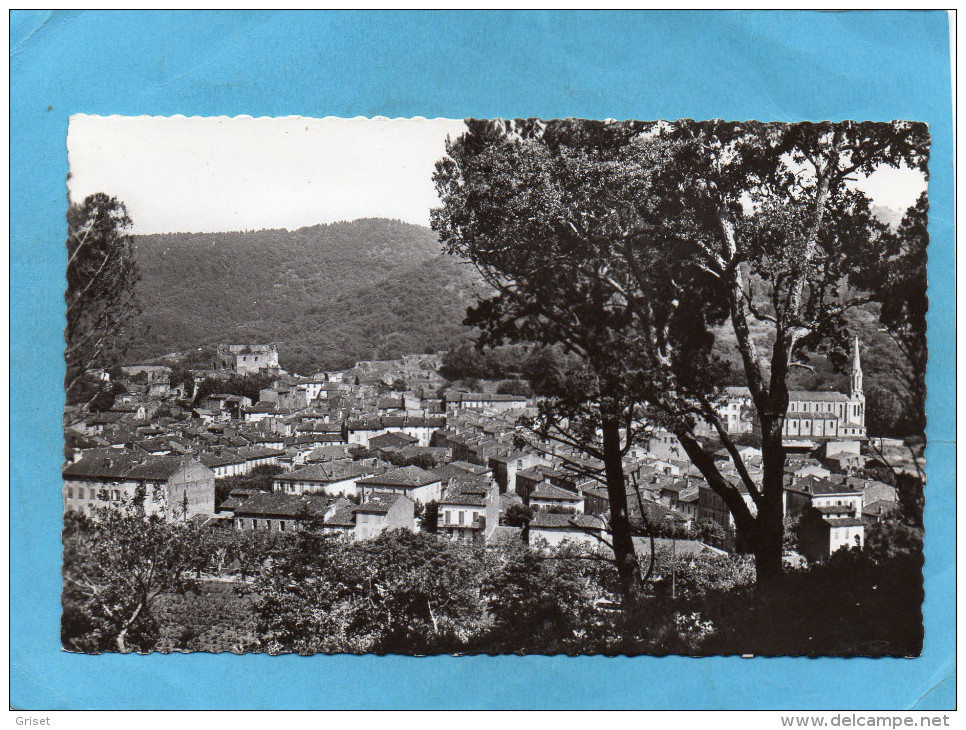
[603,416,643,610]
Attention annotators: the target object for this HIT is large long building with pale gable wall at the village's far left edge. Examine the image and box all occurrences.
[62,450,215,521]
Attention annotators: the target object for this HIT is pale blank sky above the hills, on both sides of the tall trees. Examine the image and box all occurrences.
[67,115,925,234]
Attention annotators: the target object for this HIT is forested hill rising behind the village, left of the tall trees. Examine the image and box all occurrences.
[131,219,481,372]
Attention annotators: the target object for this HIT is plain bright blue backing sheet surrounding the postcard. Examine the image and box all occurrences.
[10,11,955,709]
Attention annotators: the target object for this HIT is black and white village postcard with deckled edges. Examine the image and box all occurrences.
[62,115,938,661]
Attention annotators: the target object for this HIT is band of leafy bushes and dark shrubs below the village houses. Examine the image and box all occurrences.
[62,509,923,656]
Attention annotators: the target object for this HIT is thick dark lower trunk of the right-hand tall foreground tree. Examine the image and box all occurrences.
[752,416,785,590]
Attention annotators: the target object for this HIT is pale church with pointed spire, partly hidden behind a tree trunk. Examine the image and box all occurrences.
[718,337,866,440]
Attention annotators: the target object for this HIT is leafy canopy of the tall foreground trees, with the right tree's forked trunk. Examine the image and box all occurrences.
[432,119,929,584]
